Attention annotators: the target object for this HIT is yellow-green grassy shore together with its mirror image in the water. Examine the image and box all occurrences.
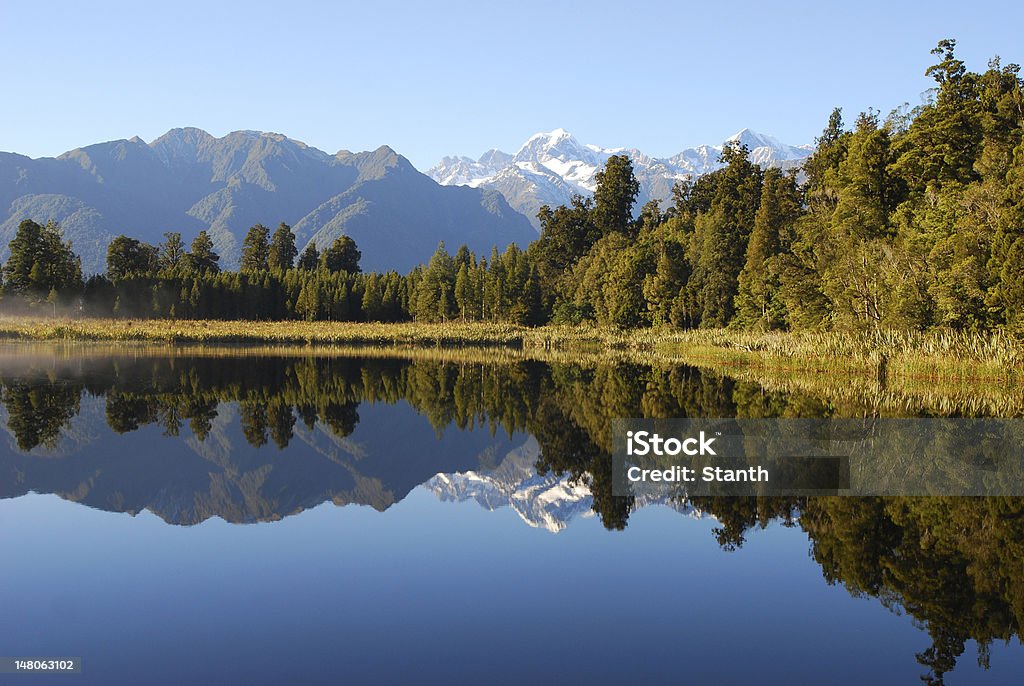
[0,319,1024,415]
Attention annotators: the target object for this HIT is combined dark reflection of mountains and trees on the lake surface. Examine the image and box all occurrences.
[0,348,1024,683]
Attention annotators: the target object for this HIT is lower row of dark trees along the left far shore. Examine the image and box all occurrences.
[2,219,544,325]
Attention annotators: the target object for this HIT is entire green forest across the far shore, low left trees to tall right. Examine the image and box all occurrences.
[2,39,1024,333]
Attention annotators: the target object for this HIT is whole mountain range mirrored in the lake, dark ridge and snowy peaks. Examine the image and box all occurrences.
[0,396,703,533]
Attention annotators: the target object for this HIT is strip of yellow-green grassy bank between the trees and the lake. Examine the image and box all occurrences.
[0,318,1024,385]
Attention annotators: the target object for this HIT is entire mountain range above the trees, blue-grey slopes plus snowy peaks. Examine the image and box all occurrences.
[0,128,812,274]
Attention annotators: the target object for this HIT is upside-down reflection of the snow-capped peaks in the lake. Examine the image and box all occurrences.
[423,437,705,533]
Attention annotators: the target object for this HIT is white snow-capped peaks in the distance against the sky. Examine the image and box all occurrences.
[427,129,813,228]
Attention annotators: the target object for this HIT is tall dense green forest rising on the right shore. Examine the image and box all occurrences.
[534,41,1024,330]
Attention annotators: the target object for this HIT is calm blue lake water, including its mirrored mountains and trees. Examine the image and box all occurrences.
[0,346,1024,685]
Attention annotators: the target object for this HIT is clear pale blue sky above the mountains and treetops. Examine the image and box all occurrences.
[0,0,1024,169]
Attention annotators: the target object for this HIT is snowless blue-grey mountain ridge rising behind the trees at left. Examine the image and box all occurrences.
[0,128,537,273]
